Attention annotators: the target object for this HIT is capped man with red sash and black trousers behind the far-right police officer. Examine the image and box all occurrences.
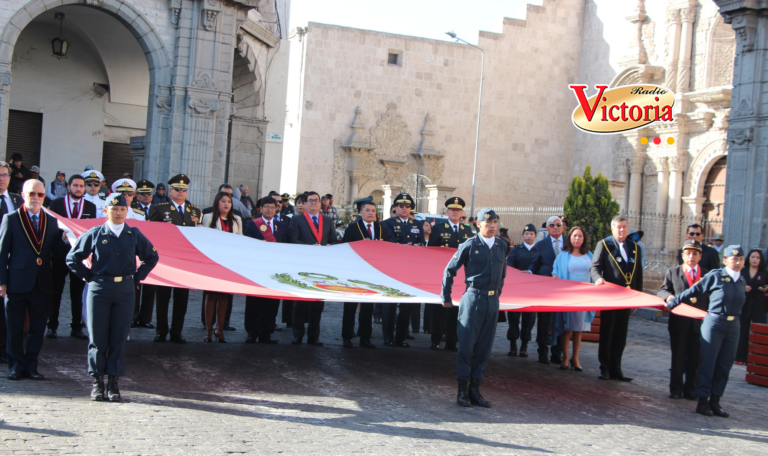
[659,239,709,401]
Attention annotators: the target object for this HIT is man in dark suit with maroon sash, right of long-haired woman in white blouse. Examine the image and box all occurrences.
[243,196,288,344]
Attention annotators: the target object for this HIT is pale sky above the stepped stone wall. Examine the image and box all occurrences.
[290,0,543,44]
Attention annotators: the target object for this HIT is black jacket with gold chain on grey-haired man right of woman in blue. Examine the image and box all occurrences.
[589,236,643,291]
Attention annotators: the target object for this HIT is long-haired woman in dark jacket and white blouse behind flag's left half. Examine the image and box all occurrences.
[201,192,243,343]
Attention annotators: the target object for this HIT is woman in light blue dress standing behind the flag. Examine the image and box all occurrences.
[552,226,595,372]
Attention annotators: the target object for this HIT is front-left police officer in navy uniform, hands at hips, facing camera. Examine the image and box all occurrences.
[67,194,158,402]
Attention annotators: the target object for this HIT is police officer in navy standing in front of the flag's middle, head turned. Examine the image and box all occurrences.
[440,209,507,407]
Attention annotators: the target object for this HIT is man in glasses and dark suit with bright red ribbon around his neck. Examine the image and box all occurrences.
[288,192,339,347]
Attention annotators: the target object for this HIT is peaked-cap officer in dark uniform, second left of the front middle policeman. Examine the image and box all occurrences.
[381,193,426,348]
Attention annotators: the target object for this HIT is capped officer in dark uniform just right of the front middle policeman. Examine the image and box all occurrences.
[503,223,539,358]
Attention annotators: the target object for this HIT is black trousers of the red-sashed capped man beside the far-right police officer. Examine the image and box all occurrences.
[672,320,701,395]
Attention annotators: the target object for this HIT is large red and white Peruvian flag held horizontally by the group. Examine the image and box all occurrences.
[52,219,703,317]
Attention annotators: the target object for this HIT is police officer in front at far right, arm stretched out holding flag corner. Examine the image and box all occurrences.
[666,245,747,418]
